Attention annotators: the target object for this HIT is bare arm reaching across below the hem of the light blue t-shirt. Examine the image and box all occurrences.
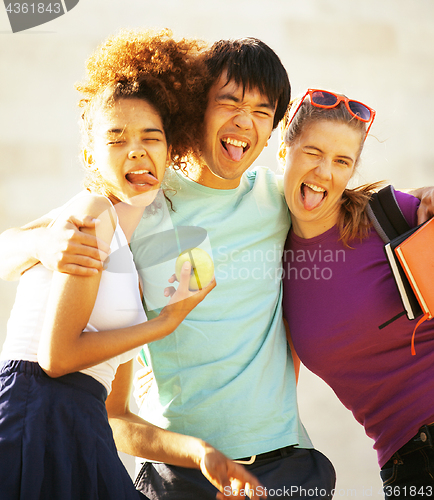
[106,361,261,499]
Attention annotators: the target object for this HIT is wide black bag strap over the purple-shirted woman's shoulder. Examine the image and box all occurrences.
[367,185,410,243]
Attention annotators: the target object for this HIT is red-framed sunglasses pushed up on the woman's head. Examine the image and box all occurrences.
[287,89,375,139]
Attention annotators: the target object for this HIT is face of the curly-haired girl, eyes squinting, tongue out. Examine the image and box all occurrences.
[85,99,168,206]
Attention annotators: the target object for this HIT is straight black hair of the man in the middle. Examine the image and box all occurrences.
[205,38,291,129]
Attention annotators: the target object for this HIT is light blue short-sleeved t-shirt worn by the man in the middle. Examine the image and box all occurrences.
[131,168,312,458]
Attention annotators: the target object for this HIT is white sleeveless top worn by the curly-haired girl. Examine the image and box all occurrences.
[0,196,146,393]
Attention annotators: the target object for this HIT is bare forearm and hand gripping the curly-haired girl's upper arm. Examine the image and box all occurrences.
[0,216,109,280]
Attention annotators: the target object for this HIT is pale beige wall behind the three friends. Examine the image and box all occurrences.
[0,0,434,498]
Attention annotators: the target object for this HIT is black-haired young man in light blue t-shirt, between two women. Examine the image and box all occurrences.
[125,39,335,499]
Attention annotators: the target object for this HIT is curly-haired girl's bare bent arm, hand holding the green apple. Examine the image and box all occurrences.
[38,196,215,377]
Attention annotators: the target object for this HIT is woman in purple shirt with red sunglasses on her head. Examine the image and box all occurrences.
[280,90,434,498]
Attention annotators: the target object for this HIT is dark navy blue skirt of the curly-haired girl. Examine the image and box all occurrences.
[0,361,146,500]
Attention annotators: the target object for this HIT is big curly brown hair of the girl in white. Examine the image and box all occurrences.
[76,29,208,192]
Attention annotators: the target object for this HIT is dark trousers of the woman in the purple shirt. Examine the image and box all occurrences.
[380,425,434,499]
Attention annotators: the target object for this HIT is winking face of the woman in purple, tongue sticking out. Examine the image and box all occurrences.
[284,120,363,238]
